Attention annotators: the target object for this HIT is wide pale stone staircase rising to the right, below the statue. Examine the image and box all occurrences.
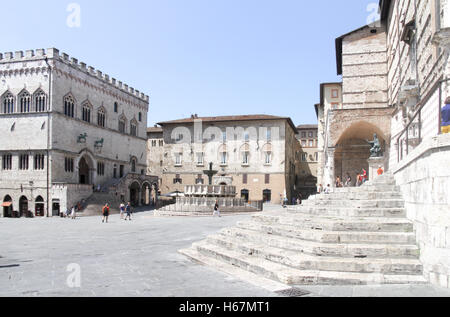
[180,175,427,285]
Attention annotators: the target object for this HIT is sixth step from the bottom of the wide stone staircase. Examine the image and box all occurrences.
[287,205,406,218]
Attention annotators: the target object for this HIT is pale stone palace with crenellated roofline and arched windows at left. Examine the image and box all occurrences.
[0,48,157,217]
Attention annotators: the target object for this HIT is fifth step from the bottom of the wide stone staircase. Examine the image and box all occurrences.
[252,213,414,232]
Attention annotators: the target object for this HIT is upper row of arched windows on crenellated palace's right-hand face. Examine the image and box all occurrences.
[64,95,142,136]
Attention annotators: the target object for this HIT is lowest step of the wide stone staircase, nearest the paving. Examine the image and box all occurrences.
[188,242,426,285]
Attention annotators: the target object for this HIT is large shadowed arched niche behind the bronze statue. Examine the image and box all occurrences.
[331,121,387,183]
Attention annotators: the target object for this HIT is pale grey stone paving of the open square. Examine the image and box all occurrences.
[0,212,450,297]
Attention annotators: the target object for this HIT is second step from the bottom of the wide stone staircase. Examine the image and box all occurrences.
[207,235,423,275]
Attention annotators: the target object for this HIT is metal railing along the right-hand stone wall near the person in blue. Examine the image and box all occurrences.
[396,79,450,162]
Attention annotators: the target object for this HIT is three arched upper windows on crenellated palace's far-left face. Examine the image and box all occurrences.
[1,89,47,114]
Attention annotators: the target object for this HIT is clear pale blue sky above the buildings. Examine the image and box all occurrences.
[0,0,378,126]
